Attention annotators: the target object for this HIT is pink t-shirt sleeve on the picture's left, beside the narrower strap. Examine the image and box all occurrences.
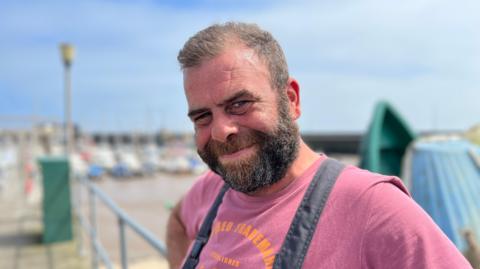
[180,172,223,240]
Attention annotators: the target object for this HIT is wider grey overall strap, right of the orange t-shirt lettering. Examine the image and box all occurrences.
[273,159,344,269]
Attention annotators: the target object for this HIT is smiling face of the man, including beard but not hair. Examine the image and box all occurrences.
[184,44,298,193]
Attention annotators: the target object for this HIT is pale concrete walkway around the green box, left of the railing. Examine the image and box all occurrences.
[0,168,90,269]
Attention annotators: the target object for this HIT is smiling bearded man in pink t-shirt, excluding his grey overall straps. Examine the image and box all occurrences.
[167,23,470,268]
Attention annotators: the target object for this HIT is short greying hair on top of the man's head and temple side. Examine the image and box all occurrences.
[177,22,289,91]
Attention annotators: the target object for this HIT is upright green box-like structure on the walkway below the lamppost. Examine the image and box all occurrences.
[39,157,72,243]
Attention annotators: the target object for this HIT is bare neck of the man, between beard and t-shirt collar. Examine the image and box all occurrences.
[248,139,318,197]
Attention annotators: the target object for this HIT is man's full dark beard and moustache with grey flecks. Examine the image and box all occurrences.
[198,96,299,194]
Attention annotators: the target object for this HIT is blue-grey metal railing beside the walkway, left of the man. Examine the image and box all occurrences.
[74,177,167,269]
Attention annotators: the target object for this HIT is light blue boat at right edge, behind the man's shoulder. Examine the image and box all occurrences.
[404,136,480,252]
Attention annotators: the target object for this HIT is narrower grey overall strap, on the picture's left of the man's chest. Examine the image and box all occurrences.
[182,184,229,269]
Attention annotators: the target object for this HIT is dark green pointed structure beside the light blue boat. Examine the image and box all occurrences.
[360,101,415,176]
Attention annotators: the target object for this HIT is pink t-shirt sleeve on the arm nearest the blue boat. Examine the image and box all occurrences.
[362,182,471,269]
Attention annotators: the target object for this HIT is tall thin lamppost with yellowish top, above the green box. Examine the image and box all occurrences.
[60,43,75,154]
